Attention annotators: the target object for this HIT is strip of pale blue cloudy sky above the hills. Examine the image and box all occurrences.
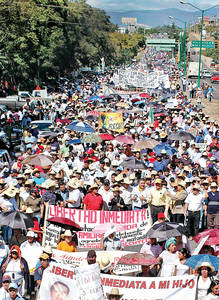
[87,0,218,11]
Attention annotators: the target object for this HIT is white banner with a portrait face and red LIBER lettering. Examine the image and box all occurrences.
[38,263,104,300]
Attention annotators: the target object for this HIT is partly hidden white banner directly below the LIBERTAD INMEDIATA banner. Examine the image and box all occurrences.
[52,249,140,275]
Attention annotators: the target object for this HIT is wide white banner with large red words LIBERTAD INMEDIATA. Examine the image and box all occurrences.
[45,205,151,248]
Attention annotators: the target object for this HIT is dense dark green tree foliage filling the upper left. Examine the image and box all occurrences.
[0,0,116,88]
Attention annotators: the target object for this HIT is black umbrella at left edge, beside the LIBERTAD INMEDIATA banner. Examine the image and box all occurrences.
[0,211,34,229]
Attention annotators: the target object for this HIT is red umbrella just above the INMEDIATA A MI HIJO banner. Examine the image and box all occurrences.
[118,253,159,266]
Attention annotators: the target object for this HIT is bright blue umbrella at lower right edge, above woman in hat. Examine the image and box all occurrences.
[185,254,219,271]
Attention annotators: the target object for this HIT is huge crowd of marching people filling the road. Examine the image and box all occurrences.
[0,48,219,300]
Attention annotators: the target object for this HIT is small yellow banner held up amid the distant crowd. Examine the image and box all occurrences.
[99,112,124,132]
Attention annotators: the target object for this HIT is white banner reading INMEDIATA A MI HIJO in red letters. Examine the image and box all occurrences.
[101,274,197,300]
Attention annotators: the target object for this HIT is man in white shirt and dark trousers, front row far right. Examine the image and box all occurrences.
[184,184,204,240]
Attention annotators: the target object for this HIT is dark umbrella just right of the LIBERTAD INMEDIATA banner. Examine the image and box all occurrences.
[147,222,183,241]
